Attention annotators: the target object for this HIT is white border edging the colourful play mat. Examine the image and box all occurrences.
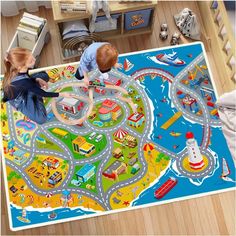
[0,41,236,232]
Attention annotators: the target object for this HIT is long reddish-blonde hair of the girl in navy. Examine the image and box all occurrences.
[2,48,31,96]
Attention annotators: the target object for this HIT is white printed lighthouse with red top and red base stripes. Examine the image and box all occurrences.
[186,132,205,170]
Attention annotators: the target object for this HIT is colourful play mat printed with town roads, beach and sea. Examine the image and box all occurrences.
[1,43,235,230]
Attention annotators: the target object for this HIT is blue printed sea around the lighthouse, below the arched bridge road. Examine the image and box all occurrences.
[133,77,236,206]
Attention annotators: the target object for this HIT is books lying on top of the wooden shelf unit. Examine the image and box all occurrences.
[59,0,87,13]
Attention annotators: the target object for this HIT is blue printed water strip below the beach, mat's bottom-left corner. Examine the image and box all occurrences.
[11,205,95,227]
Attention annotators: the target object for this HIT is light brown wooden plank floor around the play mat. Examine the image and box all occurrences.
[1,1,236,235]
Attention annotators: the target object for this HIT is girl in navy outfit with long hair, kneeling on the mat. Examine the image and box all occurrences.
[3,48,71,124]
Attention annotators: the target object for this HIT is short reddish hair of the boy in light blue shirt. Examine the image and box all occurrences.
[96,44,118,71]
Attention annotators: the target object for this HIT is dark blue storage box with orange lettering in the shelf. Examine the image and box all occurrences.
[125,9,152,30]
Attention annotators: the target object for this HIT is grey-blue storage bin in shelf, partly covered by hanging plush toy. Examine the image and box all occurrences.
[95,14,121,32]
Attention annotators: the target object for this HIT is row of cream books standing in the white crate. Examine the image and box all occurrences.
[17,12,46,50]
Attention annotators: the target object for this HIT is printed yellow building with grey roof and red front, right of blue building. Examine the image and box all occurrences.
[102,160,127,180]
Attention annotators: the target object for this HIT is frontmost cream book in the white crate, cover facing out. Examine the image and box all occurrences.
[17,26,38,50]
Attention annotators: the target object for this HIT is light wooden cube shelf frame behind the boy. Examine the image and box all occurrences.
[52,0,157,60]
